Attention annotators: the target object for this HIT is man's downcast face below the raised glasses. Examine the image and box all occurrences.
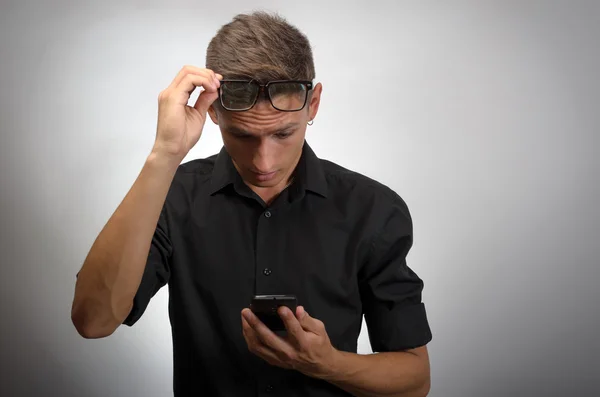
[209,84,322,189]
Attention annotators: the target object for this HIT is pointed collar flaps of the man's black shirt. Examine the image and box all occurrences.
[210,140,327,199]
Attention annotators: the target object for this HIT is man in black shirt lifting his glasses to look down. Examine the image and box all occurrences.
[72,13,431,397]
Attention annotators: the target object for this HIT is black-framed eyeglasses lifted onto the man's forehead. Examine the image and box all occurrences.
[219,80,313,112]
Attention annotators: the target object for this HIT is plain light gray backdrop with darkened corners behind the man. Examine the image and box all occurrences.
[0,0,600,397]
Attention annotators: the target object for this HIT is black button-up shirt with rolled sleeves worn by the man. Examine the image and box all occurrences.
[124,142,432,397]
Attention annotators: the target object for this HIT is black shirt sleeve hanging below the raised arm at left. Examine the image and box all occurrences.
[123,207,173,327]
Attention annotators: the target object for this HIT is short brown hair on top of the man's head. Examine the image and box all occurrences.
[206,11,315,83]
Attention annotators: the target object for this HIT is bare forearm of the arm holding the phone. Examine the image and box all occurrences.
[319,350,430,397]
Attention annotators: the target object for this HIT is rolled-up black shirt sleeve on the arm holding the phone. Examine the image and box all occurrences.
[359,195,432,352]
